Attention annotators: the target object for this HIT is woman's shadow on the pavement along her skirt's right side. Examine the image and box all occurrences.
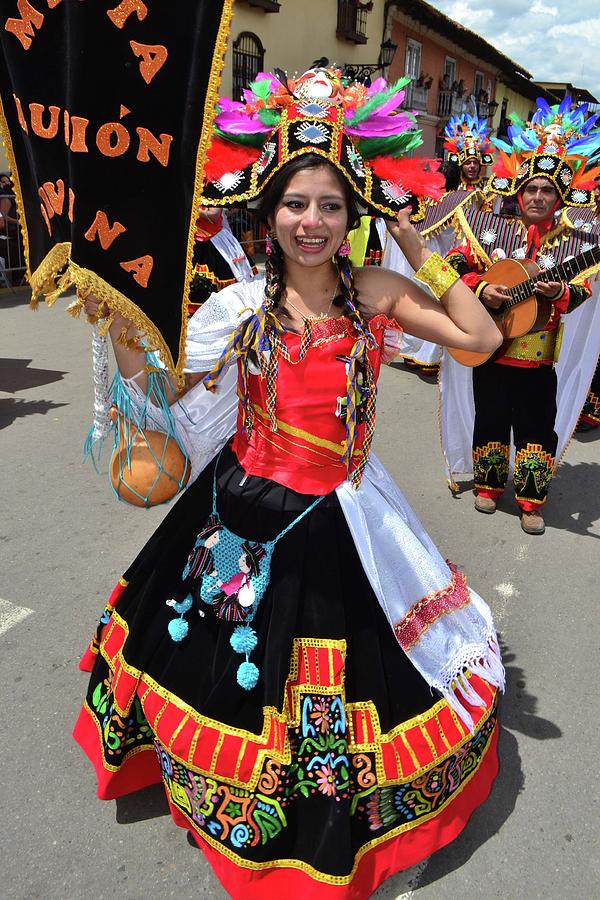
[417,641,562,893]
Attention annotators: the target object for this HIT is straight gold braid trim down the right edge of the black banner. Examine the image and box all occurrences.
[180,0,233,385]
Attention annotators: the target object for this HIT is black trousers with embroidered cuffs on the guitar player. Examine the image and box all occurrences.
[473,362,558,508]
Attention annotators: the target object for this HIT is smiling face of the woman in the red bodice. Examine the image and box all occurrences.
[269,165,348,266]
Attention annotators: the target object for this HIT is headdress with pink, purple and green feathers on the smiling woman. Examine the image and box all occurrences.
[200,68,444,221]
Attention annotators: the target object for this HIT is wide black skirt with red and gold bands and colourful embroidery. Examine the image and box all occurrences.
[75,448,496,898]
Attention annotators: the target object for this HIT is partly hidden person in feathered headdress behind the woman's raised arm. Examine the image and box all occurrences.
[383,113,492,375]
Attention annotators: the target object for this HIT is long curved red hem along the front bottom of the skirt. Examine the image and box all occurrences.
[169,729,498,900]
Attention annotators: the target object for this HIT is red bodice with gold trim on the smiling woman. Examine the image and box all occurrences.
[233,315,398,495]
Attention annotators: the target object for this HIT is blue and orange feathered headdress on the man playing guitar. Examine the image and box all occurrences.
[489,97,600,206]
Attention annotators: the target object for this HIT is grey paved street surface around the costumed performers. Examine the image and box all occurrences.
[0,291,600,900]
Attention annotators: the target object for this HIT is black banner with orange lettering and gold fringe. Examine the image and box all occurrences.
[0,0,233,369]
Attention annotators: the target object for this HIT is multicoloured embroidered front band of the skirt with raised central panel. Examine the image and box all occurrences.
[156,694,495,857]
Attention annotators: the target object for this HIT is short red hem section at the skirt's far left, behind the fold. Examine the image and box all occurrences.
[73,706,162,800]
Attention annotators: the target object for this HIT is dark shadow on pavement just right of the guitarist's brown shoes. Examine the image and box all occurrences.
[544,462,600,538]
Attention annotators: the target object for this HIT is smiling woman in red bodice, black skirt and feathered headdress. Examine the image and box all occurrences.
[75,71,503,900]
